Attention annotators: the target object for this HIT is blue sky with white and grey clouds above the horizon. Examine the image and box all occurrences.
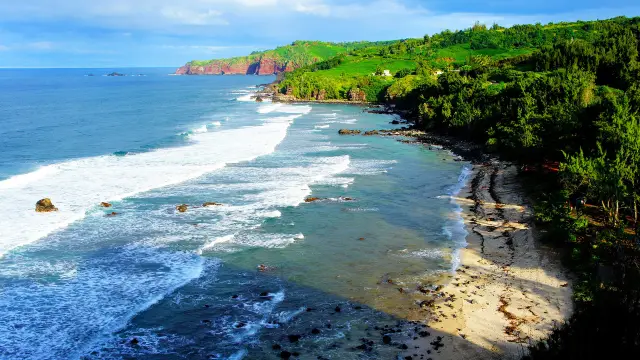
[0,0,640,68]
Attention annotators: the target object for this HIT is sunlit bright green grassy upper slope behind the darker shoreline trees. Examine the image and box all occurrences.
[280,21,620,102]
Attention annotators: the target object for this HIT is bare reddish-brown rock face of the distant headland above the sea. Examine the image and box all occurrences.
[176,57,296,75]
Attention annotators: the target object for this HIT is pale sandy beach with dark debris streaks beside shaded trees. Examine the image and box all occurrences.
[403,160,572,360]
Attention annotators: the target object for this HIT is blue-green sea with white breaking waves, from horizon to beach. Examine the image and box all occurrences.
[0,69,466,359]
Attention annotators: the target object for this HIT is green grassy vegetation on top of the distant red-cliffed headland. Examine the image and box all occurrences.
[187,41,393,67]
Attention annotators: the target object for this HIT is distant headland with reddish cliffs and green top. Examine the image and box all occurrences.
[176,41,391,75]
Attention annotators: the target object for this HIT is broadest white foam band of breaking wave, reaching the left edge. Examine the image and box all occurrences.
[0,119,298,256]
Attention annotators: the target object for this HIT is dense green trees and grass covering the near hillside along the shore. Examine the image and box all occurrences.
[280,17,640,359]
